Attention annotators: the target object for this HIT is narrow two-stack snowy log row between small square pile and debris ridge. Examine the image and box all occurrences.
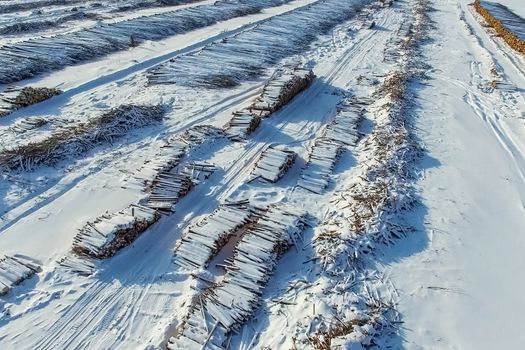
[297,99,363,194]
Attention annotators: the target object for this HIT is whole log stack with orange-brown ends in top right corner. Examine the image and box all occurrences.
[474,0,525,55]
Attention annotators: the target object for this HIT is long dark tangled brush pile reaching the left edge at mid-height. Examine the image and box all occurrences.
[0,105,165,170]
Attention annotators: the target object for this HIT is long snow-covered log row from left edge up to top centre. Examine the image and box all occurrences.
[0,0,291,84]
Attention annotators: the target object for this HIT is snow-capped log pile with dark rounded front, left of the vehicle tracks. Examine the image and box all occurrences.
[73,205,160,259]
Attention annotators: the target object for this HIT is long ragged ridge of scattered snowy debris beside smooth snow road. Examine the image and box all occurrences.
[294,0,428,349]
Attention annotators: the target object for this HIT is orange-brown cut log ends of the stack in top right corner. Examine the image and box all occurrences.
[473,0,525,55]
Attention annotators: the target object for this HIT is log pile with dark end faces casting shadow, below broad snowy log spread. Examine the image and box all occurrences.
[227,67,315,141]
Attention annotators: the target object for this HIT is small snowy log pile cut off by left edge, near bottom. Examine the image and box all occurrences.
[0,255,41,295]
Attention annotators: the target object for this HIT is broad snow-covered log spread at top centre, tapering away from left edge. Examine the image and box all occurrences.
[148,0,361,89]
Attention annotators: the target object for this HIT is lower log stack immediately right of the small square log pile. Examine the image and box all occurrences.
[297,138,342,194]
